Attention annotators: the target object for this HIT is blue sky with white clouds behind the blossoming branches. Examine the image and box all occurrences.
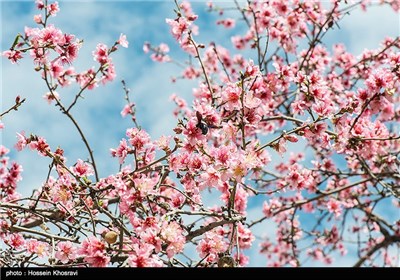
[0,0,400,265]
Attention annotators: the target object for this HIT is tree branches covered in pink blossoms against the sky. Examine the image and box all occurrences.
[0,0,400,267]
